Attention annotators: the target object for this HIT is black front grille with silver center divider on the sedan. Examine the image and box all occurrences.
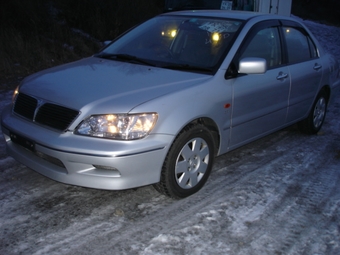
[13,93,79,131]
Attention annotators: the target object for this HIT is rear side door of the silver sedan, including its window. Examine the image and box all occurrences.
[283,21,323,123]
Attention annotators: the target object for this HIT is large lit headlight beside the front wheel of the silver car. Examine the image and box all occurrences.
[75,113,158,140]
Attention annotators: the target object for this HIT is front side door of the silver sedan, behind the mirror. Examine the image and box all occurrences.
[229,20,290,149]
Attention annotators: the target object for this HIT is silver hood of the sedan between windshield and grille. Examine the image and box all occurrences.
[20,57,211,113]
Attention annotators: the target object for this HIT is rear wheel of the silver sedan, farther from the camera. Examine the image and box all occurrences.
[298,91,328,134]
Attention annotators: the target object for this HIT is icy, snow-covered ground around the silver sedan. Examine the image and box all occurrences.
[0,16,340,255]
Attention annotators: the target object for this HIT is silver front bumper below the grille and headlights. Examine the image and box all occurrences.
[2,107,173,190]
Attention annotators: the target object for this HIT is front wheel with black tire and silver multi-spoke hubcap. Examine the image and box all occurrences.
[154,124,214,198]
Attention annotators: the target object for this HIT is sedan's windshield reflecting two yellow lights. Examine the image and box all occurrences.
[97,15,242,72]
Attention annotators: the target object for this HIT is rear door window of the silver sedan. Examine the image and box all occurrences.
[283,27,318,64]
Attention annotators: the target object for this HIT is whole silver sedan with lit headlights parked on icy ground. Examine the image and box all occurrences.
[1,10,340,198]
